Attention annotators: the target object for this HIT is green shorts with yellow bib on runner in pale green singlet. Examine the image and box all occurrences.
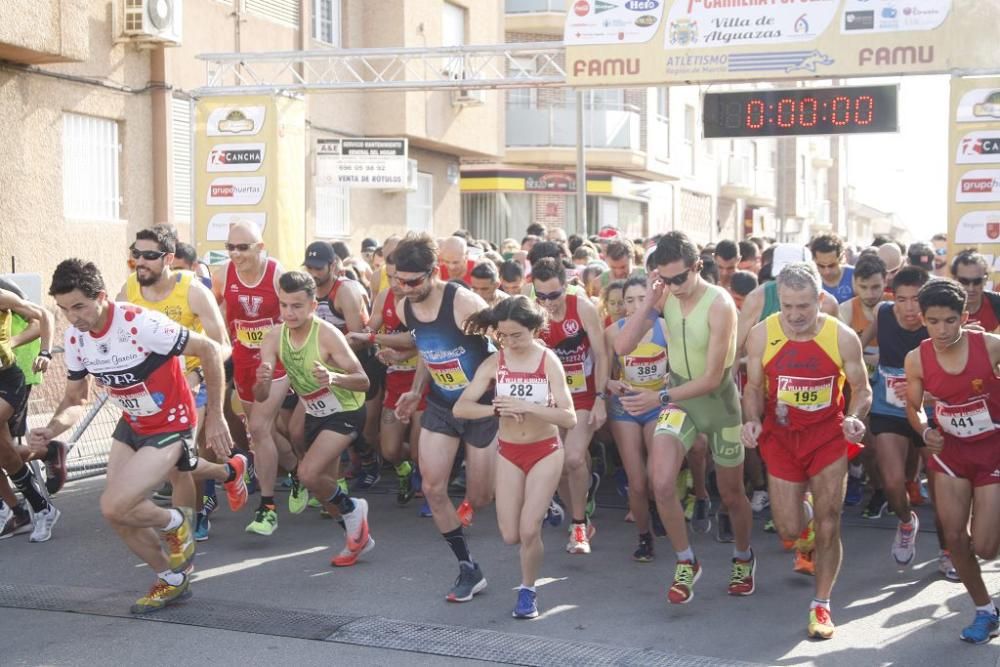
[656,372,744,468]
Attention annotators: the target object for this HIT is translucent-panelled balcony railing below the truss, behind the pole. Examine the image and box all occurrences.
[507,104,641,151]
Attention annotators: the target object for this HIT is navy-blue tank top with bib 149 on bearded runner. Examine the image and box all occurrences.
[403,283,494,409]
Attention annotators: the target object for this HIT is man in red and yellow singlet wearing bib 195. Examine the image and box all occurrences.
[740,262,871,639]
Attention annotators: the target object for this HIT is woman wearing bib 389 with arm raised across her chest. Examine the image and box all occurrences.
[604,278,667,563]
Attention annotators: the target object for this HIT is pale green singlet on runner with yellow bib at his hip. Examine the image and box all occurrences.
[663,285,736,380]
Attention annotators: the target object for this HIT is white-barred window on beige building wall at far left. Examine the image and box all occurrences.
[62,113,121,221]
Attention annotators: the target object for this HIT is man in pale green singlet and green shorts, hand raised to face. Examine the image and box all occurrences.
[615,232,757,604]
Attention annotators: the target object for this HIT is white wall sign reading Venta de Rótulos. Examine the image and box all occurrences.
[316,137,409,190]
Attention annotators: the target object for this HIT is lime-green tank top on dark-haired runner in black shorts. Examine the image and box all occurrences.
[279,317,365,417]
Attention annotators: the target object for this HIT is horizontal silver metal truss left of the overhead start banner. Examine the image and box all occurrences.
[195,42,566,96]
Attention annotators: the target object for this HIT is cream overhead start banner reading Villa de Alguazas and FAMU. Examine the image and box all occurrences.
[563,0,1000,87]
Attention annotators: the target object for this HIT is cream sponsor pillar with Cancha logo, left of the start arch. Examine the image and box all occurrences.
[194,95,306,267]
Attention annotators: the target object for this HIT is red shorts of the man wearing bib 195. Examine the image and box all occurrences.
[760,429,849,482]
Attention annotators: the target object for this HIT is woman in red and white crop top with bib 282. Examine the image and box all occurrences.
[455,296,576,618]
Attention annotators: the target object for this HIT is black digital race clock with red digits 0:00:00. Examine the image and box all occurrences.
[702,85,899,139]
